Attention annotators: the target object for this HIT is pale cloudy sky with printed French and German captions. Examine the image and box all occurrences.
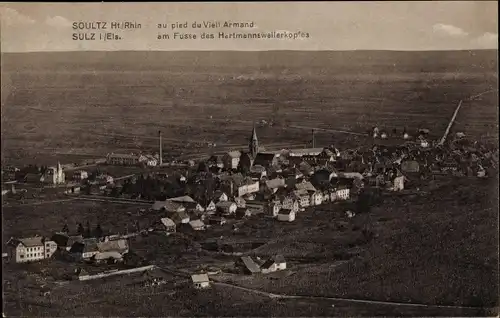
[0,1,498,52]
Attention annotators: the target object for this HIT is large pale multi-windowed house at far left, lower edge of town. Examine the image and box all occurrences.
[7,236,57,263]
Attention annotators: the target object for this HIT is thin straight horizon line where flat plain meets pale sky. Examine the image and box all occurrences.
[0,48,498,54]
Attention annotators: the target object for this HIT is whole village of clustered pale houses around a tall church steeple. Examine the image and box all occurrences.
[2,116,498,298]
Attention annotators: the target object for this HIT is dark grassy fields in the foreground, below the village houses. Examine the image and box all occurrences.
[3,179,499,316]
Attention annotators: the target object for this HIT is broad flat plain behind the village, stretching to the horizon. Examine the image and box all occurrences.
[2,51,498,163]
